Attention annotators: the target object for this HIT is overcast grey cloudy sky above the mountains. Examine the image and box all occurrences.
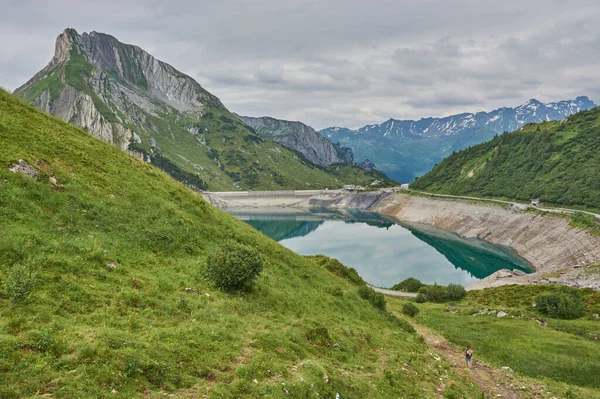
[0,0,600,128]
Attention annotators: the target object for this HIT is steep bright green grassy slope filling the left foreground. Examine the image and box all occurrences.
[0,91,480,398]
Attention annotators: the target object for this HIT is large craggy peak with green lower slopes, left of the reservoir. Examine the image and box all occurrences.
[15,29,394,191]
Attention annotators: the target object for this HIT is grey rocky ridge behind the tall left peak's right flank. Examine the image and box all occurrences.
[235,114,354,166]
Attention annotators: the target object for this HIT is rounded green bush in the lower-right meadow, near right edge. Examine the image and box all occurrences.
[535,287,585,319]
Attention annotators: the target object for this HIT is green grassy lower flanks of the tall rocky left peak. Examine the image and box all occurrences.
[17,44,394,191]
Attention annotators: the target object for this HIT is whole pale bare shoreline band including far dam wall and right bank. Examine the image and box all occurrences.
[203,190,600,289]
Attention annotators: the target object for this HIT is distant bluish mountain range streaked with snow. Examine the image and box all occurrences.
[321,96,596,183]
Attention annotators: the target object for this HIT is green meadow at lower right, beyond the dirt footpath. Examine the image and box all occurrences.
[388,285,600,399]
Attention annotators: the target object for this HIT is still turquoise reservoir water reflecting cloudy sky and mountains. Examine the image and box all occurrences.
[229,208,533,287]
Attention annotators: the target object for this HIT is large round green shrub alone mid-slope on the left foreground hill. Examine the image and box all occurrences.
[206,240,263,292]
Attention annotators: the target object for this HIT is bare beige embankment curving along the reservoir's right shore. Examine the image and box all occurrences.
[371,194,600,288]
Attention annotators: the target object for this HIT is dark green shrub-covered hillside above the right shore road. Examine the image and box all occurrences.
[411,108,600,209]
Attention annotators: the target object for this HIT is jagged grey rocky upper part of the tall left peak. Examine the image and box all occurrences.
[15,29,223,150]
